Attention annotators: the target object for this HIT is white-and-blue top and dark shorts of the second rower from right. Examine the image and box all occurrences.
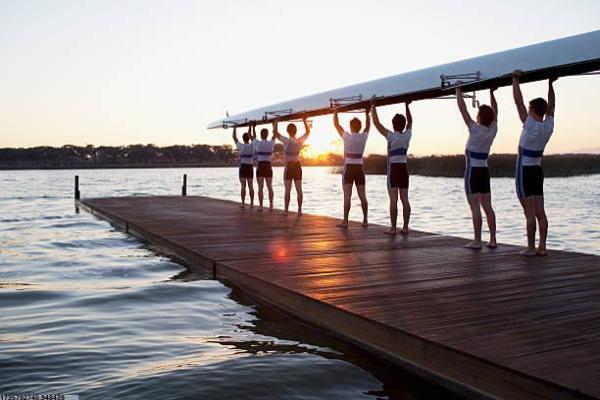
[465,121,498,194]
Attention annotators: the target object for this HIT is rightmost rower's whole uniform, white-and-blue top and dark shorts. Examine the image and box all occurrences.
[515,115,554,198]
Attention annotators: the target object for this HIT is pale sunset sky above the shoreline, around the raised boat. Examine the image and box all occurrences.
[0,0,600,155]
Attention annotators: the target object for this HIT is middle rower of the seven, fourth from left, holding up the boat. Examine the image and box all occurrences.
[333,107,371,229]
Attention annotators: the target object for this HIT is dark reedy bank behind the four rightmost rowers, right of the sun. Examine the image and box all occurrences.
[344,154,600,177]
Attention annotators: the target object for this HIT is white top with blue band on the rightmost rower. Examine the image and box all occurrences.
[519,115,554,165]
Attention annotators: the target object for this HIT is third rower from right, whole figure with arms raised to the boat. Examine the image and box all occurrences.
[371,101,413,235]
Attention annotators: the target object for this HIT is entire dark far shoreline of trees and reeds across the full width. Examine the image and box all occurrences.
[0,144,600,177]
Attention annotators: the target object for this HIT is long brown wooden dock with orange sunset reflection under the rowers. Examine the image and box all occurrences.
[79,197,600,399]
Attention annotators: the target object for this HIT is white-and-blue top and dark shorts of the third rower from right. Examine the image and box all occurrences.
[386,129,412,189]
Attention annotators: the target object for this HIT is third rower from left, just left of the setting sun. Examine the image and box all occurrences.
[273,117,310,215]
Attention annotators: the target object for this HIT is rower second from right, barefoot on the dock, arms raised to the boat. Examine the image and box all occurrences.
[455,81,498,249]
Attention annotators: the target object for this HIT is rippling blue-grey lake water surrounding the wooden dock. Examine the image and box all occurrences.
[0,168,600,399]
